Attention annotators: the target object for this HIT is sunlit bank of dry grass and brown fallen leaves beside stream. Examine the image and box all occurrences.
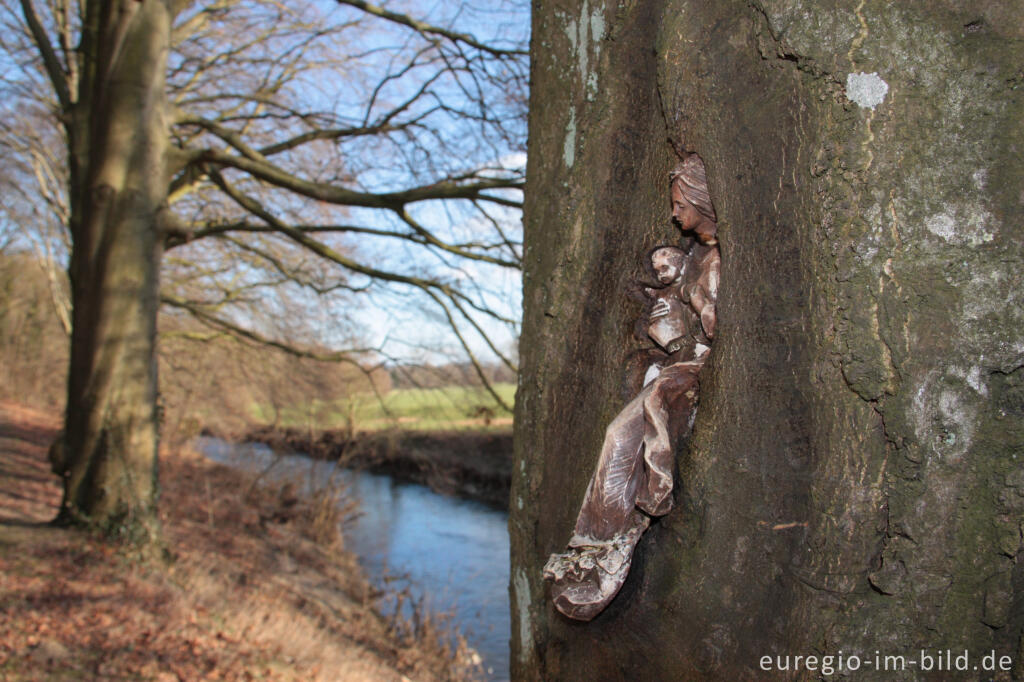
[0,403,481,682]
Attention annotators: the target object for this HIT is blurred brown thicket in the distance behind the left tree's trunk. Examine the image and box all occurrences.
[0,250,515,441]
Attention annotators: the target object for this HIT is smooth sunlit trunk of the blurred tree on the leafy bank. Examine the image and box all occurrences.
[55,0,171,541]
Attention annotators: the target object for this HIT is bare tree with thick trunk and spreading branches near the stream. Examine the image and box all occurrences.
[5,0,526,539]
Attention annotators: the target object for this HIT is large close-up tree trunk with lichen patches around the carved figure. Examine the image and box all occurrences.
[510,0,1024,680]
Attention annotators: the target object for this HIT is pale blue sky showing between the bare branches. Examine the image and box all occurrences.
[0,0,529,361]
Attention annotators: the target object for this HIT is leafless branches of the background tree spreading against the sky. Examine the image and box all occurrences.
[0,0,528,402]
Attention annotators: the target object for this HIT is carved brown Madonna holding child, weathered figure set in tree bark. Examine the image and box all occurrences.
[544,155,721,621]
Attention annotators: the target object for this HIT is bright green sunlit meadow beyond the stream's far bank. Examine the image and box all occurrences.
[253,383,515,431]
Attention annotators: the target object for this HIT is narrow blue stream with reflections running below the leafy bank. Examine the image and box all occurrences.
[197,437,510,680]
